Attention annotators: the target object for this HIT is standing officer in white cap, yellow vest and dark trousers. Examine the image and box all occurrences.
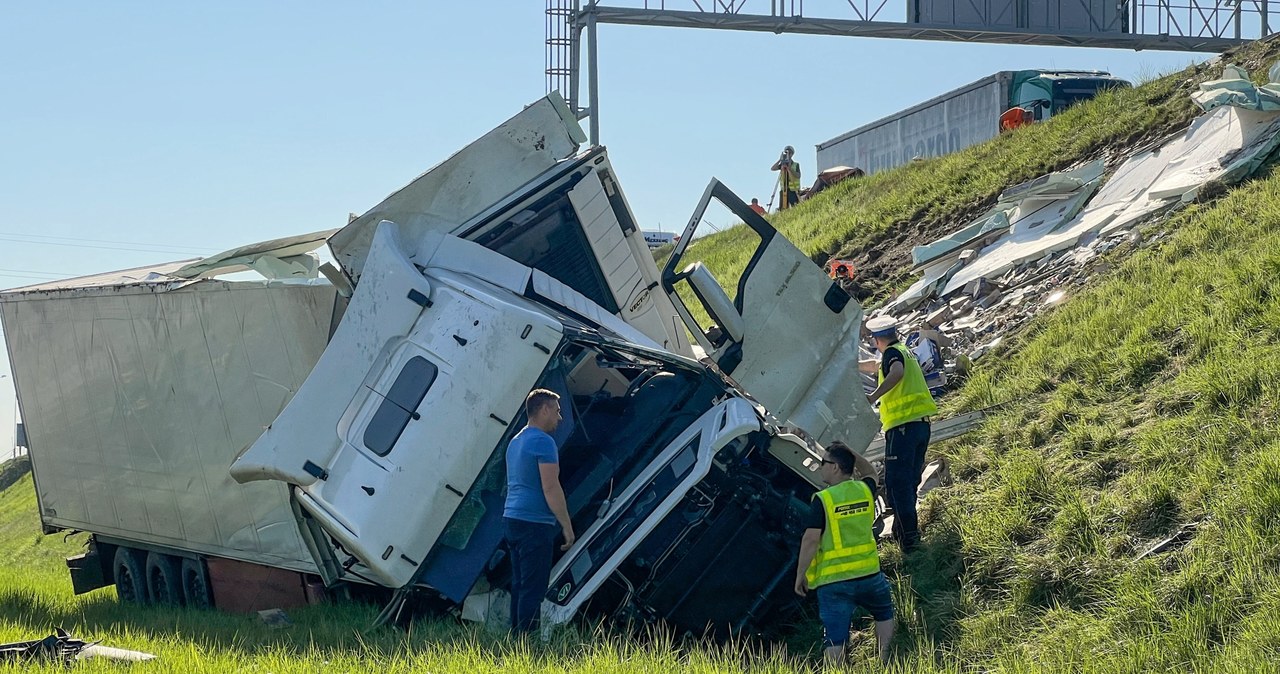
[859,316,938,553]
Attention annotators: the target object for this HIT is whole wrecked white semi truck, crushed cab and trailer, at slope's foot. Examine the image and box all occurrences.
[0,96,877,636]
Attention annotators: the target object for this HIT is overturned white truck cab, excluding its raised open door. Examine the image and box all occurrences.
[230,221,856,634]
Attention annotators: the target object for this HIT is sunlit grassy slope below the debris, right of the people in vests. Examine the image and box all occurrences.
[908,168,1280,671]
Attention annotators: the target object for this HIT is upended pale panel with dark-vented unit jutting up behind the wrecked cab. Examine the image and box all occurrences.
[329,95,692,356]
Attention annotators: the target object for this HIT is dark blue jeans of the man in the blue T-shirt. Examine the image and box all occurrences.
[502,517,559,632]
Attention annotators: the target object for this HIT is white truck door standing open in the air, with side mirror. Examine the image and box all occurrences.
[662,179,878,451]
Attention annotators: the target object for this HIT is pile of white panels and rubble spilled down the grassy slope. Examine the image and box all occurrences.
[873,61,1280,390]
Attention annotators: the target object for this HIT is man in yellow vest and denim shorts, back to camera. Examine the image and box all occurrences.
[796,443,895,665]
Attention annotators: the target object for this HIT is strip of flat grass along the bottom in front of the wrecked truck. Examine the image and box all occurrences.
[0,476,819,674]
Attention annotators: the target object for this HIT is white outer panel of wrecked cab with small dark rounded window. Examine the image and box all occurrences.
[232,223,561,587]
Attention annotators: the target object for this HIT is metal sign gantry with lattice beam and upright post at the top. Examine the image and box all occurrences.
[547,0,1280,143]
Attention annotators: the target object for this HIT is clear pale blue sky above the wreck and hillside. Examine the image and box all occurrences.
[0,0,1206,441]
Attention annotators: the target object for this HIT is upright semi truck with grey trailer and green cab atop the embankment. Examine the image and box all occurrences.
[818,70,1130,174]
